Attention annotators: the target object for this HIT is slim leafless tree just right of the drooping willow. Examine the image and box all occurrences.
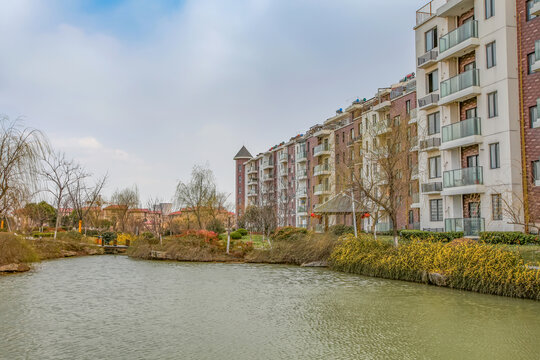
[40,153,80,239]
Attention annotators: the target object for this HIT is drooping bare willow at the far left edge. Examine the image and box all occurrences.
[0,117,49,226]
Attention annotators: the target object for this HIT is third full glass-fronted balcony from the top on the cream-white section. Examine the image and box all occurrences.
[441,118,482,150]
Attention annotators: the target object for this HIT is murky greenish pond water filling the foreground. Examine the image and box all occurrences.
[0,255,540,360]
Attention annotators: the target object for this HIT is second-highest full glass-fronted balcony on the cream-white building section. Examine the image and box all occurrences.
[439,69,481,105]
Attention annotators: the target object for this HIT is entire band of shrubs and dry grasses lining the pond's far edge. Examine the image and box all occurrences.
[0,228,540,300]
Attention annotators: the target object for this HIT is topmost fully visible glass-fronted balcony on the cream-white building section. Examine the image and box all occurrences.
[437,20,480,61]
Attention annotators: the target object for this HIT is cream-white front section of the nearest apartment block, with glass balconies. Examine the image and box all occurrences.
[414,0,523,236]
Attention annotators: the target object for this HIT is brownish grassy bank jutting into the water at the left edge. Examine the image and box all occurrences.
[0,233,103,274]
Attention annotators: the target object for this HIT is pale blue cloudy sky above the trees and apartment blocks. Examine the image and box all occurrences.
[0,0,427,207]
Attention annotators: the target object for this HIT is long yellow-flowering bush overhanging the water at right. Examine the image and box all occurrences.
[330,235,540,300]
